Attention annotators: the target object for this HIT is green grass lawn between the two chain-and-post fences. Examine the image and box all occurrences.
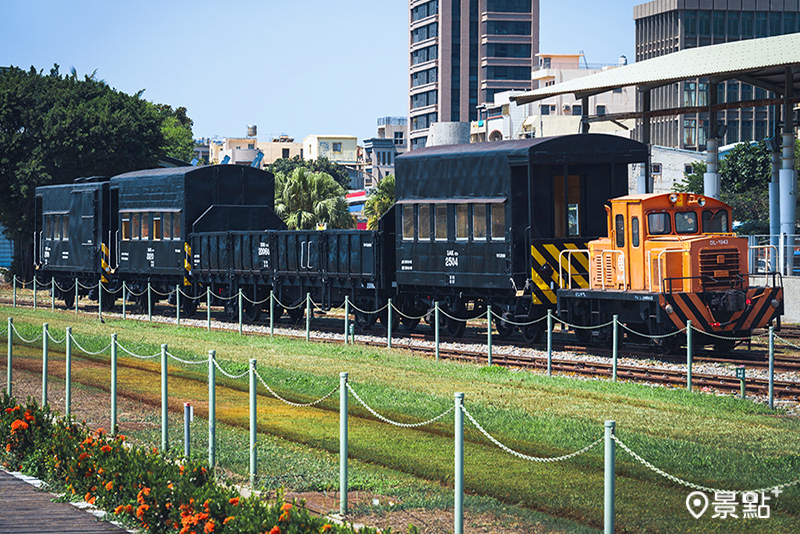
[3,308,800,533]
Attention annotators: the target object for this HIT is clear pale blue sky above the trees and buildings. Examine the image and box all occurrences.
[0,0,642,141]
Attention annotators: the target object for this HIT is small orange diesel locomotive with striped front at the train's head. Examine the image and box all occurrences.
[558,193,783,352]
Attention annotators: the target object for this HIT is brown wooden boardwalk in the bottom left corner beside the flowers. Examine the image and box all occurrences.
[0,470,127,534]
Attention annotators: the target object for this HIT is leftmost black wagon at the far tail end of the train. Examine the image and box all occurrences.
[34,176,117,307]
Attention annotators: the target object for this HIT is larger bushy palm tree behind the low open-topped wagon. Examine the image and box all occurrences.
[275,166,355,230]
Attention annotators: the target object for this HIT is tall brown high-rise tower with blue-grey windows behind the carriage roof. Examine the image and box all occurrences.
[408,0,539,150]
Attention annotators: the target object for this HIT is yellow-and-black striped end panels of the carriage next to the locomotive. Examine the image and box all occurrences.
[531,240,589,304]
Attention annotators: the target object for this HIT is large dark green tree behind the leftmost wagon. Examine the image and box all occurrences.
[0,65,191,274]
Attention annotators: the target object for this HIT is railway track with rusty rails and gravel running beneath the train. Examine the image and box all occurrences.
[0,297,800,401]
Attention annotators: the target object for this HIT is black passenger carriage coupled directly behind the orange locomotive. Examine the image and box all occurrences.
[395,134,648,340]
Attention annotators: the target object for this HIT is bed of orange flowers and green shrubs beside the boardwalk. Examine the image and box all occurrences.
[0,394,414,534]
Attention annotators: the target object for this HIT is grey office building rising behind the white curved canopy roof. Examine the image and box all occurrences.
[633,0,800,150]
